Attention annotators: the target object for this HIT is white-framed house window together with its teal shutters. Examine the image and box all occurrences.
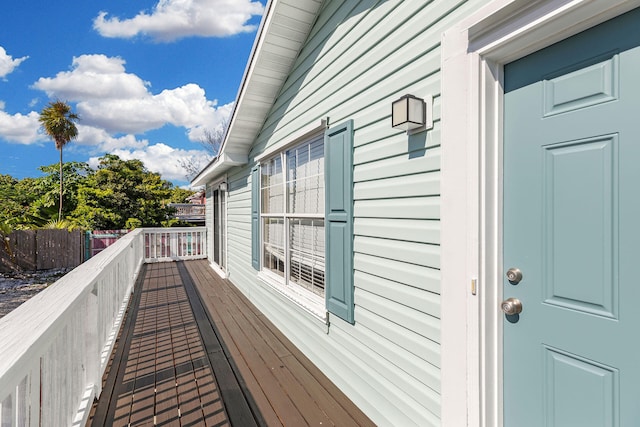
[251,120,355,323]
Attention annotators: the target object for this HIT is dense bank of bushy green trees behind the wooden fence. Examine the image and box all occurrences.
[0,155,193,230]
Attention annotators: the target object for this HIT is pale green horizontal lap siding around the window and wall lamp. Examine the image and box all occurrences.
[218,0,484,426]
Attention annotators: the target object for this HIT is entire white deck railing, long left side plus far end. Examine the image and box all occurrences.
[0,228,206,427]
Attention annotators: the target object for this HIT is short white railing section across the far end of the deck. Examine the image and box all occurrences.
[144,227,207,262]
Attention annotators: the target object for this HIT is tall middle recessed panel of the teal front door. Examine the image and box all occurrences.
[542,135,618,318]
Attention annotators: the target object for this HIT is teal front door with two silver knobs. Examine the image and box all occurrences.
[502,9,640,427]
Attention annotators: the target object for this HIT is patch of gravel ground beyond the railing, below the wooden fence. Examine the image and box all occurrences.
[0,268,71,318]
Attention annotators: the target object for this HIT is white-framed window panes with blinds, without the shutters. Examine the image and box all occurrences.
[260,135,325,297]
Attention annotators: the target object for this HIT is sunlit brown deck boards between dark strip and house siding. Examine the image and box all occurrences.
[185,261,374,426]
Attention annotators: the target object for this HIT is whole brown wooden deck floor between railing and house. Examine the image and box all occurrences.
[90,260,373,427]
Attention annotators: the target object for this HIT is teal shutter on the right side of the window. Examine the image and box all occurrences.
[324,120,355,323]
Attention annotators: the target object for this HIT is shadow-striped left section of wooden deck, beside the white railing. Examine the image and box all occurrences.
[91,263,230,426]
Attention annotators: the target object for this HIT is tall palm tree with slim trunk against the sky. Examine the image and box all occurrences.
[38,101,80,219]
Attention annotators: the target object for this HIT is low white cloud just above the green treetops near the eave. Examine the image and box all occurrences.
[89,143,207,181]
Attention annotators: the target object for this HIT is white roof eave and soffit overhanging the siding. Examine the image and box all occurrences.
[191,0,322,186]
